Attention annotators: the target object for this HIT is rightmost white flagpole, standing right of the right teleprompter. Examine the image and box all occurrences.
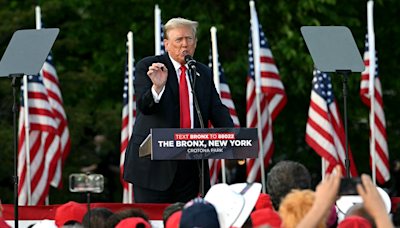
[367,0,376,185]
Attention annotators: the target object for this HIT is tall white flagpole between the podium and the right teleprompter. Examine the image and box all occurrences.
[249,1,266,193]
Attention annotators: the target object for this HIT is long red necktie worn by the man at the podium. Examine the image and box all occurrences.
[179,65,191,128]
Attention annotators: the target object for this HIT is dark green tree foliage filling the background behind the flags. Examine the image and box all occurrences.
[0,0,400,204]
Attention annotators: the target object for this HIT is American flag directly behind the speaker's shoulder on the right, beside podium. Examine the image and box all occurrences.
[208,45,240,185]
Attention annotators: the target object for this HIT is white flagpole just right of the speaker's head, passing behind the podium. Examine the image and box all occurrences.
[210,26,226,183]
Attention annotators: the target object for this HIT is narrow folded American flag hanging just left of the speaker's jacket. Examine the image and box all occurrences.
[120,44,136,203]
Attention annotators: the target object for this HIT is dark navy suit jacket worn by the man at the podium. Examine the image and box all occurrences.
[123,53,234,191]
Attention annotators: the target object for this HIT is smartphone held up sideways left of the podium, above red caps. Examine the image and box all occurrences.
[69,173,104,193]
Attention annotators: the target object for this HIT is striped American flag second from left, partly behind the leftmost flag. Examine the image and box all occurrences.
[40,54,71,189]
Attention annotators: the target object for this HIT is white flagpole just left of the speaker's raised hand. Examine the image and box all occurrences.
[128,31,134,203]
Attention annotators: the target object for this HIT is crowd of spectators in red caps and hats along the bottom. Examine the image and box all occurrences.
[0,161,400,228]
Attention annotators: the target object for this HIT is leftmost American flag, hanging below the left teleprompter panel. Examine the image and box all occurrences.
[18,74,62,205]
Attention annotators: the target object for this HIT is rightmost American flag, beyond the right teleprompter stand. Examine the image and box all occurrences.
[360,35,390,184]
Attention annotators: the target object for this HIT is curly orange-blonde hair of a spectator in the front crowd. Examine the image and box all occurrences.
[278,189,328,228]
